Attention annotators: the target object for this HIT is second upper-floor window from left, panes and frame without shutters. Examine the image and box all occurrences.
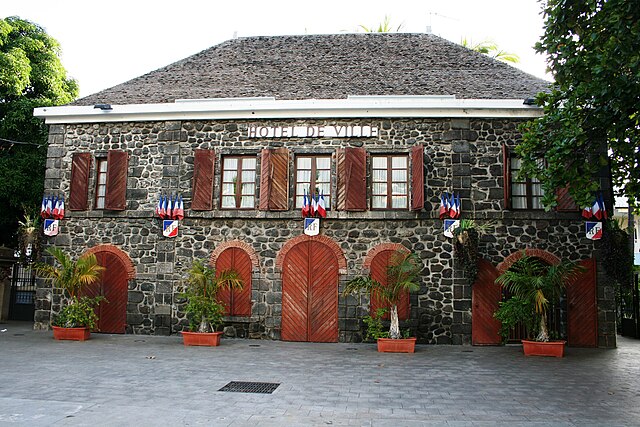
[220,156,256,209]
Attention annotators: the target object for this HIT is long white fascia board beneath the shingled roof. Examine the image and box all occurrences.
[34,96,542,124]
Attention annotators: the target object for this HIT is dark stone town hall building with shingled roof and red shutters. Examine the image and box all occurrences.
[35,34,615,347]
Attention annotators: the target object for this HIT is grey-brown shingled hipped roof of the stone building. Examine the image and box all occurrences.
[73,33,548,105]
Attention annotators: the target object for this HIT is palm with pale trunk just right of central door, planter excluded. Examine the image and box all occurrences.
[342,251,421,339]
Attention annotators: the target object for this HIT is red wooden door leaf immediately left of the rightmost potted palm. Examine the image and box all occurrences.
[471,259,502,345]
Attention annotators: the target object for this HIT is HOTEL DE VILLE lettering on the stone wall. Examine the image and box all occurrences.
[249,125,378,138]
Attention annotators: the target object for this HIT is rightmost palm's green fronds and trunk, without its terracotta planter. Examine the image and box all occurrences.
[496,255,583,342]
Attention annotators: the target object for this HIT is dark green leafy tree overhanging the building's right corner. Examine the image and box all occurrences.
[516,0,640,209]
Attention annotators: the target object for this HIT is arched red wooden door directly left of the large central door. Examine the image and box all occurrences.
[216,248,251,316]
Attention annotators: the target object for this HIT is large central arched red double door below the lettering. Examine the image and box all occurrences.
[281,241,338,342]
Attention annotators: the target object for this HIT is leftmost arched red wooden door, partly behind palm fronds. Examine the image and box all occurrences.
[82,252,128,334]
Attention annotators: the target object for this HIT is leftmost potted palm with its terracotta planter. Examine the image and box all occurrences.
[36,247,104,341]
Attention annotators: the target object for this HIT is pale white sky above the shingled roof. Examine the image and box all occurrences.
[0,0,550,96]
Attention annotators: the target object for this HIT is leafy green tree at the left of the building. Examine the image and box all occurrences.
[0,17,78,246]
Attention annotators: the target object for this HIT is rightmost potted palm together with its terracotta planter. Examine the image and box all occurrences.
[495,255,582,357]
